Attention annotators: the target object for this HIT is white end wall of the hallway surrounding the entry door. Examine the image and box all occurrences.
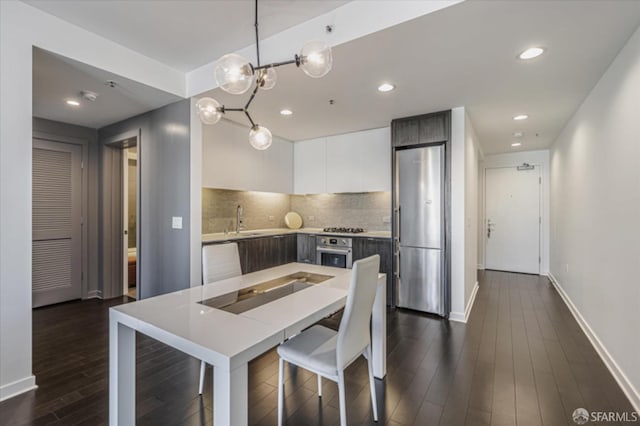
[478,149,549,275]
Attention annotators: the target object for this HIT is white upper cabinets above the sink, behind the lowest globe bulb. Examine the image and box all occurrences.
[202,121,293,194]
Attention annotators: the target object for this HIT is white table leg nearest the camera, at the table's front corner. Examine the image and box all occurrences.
[213,364,249,426]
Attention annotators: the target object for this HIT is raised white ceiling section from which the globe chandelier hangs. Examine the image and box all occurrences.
[23,0,347,72]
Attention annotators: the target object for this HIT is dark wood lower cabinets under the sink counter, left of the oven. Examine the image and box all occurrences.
[222,234,297,274]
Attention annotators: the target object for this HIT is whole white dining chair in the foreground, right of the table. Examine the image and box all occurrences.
[278,255,380,426]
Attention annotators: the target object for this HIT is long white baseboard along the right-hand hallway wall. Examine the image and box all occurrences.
[547,272,640,413]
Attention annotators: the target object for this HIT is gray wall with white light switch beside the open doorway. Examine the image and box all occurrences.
[99,99,190,299]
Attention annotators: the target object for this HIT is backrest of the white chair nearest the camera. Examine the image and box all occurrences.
[336,254,380,368]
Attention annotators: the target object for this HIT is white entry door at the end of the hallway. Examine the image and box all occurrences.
[484,166,541,274]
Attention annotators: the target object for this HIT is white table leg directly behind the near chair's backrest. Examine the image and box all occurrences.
[371,276,387,379]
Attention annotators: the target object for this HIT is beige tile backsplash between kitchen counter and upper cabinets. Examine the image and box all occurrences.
[202,188,391,234]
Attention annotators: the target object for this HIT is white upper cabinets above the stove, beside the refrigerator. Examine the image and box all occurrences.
[294,127,391,194]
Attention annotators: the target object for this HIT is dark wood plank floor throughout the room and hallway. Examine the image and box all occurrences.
[0,271,632,426]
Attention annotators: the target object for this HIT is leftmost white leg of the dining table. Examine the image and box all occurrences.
[109,317,136,426]
